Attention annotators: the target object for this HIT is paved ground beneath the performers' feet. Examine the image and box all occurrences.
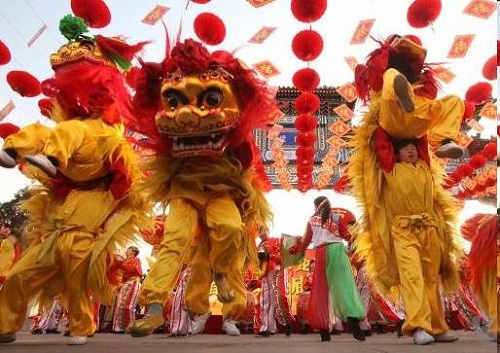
[0,331,497,353]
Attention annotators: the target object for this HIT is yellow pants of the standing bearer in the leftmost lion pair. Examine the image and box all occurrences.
[0,230,96,336]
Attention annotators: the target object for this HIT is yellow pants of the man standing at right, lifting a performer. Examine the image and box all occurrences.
[391,215,448,335]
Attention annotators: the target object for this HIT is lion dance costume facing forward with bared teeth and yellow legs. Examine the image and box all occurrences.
[123,39,276,336]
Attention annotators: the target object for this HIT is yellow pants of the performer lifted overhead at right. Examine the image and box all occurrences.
[379,69,465,147]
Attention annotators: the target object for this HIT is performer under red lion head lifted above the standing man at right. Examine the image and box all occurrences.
[355,35,465,158]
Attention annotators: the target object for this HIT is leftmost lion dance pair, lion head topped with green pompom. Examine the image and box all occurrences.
[0,15,148,344]
